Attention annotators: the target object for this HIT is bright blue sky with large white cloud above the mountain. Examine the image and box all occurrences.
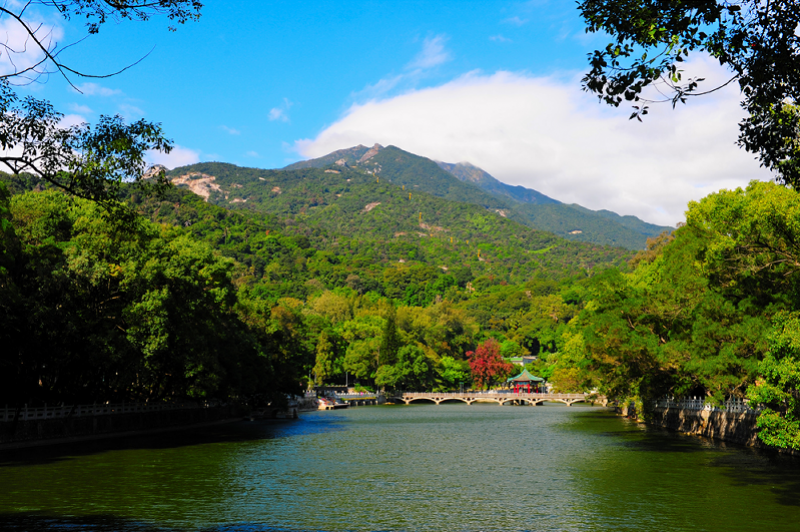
[6,0,770,224]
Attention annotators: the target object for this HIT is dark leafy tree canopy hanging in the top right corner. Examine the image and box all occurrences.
[579,0,800,187]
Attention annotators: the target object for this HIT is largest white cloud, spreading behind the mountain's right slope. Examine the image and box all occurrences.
[295,61,772,225]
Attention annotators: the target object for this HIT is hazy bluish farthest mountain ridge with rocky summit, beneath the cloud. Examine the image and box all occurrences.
[285,144,673,250]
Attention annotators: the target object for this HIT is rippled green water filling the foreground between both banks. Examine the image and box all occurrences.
[0,405,800,532]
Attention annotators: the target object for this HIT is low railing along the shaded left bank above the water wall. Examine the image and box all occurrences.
[0,403,206,422]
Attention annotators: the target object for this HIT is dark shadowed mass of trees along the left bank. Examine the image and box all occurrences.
[0,192,308,404]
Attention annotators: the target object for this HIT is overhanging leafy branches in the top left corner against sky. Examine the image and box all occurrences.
[0,0,202,208]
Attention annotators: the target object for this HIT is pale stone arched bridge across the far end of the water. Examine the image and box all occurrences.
[387,392,608,406]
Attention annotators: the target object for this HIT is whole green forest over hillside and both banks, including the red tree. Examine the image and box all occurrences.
[0,164,800,446]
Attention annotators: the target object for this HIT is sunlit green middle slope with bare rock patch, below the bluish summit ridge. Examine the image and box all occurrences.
[168,161,629,282]
